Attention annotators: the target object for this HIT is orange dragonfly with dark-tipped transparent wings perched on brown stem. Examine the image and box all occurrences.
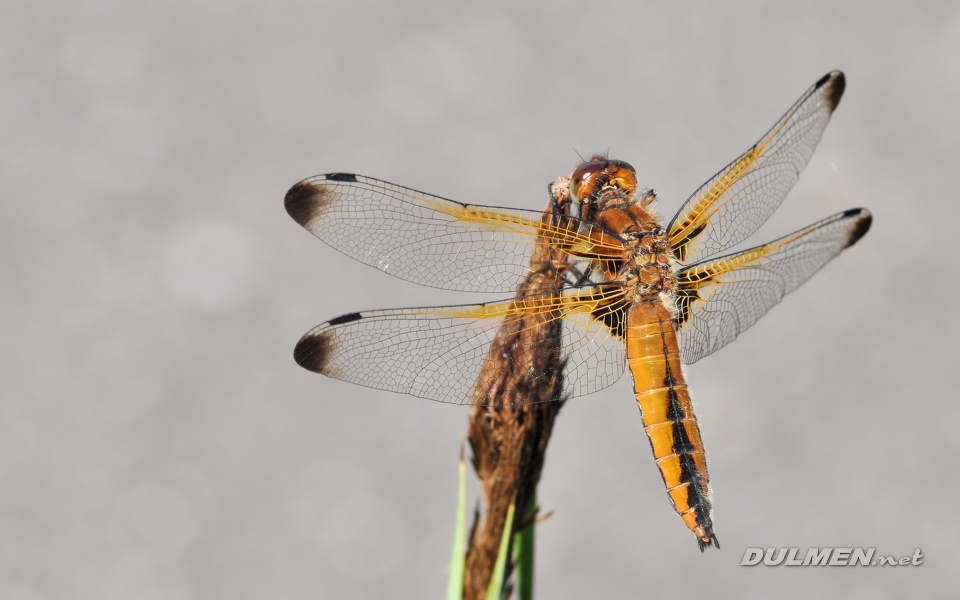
[285,71,872,552]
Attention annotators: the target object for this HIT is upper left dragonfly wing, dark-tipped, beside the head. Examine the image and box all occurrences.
[284,173,623,292]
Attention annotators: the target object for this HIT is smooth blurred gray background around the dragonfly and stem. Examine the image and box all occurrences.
[0,1,960,600]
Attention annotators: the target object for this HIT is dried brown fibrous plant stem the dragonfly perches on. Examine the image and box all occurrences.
[464,178,569,600]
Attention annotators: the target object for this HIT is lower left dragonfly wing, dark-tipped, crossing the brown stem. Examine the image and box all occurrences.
[294,284,627,404]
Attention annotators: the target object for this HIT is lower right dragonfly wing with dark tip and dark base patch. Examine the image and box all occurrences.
[677,208,871,364]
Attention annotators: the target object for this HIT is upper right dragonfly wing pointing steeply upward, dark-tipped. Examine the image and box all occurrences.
[668,71,845,263]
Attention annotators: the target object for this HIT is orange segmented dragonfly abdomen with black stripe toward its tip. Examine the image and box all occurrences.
[626,297,719,550]
